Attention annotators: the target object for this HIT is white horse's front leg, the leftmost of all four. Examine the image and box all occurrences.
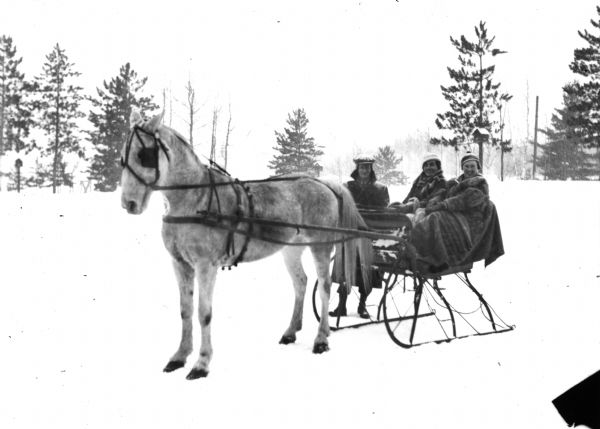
[163,259,194,372]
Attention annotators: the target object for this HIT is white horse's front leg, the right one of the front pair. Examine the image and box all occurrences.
[186,263,218,380]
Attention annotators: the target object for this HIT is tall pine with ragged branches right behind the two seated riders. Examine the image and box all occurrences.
[430,22,512,170]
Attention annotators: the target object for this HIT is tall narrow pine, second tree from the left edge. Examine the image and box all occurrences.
[36,43,85,193]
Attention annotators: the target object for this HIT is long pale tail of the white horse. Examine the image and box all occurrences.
[333,186,373,292]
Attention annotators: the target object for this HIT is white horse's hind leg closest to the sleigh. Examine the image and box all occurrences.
[310,245,333,353]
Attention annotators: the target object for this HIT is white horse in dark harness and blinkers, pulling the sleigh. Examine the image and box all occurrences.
[121,111,371,379]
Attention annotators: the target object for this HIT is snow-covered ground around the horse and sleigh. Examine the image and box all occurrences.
[0,181,600,429]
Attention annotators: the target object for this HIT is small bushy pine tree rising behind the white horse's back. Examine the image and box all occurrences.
[269,109,323,176]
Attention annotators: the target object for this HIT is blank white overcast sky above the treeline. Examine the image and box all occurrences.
[0,0,597,178]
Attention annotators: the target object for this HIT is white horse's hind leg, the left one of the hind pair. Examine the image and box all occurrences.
[279,246,307,344]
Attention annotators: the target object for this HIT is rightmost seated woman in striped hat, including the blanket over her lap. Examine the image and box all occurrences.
[411,153,504,272]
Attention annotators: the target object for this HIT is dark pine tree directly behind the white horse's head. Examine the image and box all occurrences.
[89,63,158,191]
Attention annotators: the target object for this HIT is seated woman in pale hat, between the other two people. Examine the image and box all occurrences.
[390,153,446,213]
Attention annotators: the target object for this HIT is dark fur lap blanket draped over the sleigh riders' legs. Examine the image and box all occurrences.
[411,201,504,273]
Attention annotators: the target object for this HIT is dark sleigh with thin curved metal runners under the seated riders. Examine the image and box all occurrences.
[312,209,514,348]
